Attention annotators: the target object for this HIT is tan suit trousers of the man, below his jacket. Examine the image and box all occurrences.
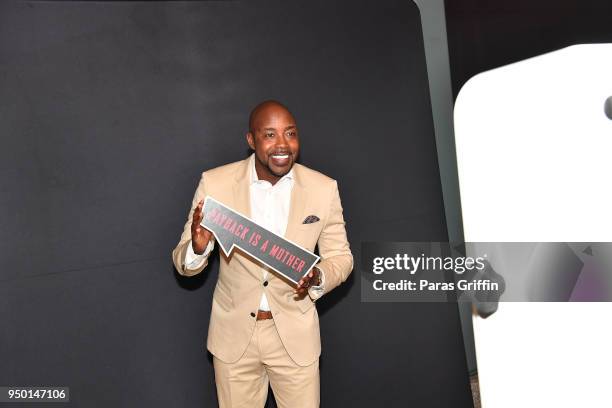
[213,319,319,408]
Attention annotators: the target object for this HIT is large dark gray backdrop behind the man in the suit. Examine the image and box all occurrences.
[0,1,471,407]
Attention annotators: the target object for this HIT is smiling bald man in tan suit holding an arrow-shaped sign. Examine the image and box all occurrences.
[172,101,353,408]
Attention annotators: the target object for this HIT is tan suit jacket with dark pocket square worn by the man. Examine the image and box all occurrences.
[172,159,353,366]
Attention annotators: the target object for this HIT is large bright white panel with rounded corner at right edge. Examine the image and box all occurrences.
[455,44,612,408]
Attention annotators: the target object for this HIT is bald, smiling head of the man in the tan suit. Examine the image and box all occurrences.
[247,101,300,184]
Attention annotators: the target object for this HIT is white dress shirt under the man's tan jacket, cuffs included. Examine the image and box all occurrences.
[185,154,325,310]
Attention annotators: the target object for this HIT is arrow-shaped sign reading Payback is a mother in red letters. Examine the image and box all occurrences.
[200,197,320,285]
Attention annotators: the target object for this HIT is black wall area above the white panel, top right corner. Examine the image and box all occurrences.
[445,0,612,96]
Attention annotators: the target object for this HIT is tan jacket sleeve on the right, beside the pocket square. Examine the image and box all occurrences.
[316,181,353,294]
